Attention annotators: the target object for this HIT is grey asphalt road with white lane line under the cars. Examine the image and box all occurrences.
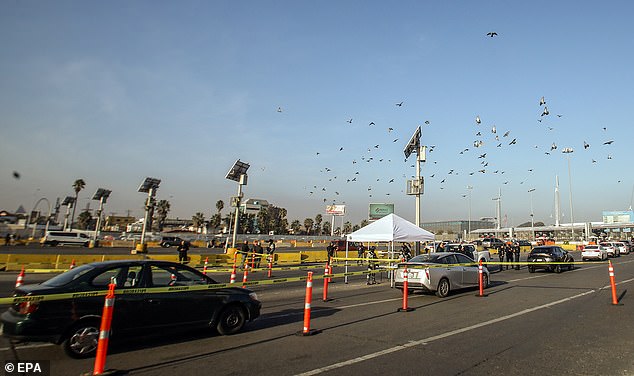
[0,254,634,376]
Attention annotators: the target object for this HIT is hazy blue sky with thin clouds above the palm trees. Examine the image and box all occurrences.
[0,1,634,225]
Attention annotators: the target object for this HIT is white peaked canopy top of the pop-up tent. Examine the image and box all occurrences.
[346,214,434,242]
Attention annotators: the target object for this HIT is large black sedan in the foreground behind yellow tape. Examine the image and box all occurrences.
[0,260,261,358]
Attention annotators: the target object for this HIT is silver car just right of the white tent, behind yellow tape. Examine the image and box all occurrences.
[394,252,489,298]
